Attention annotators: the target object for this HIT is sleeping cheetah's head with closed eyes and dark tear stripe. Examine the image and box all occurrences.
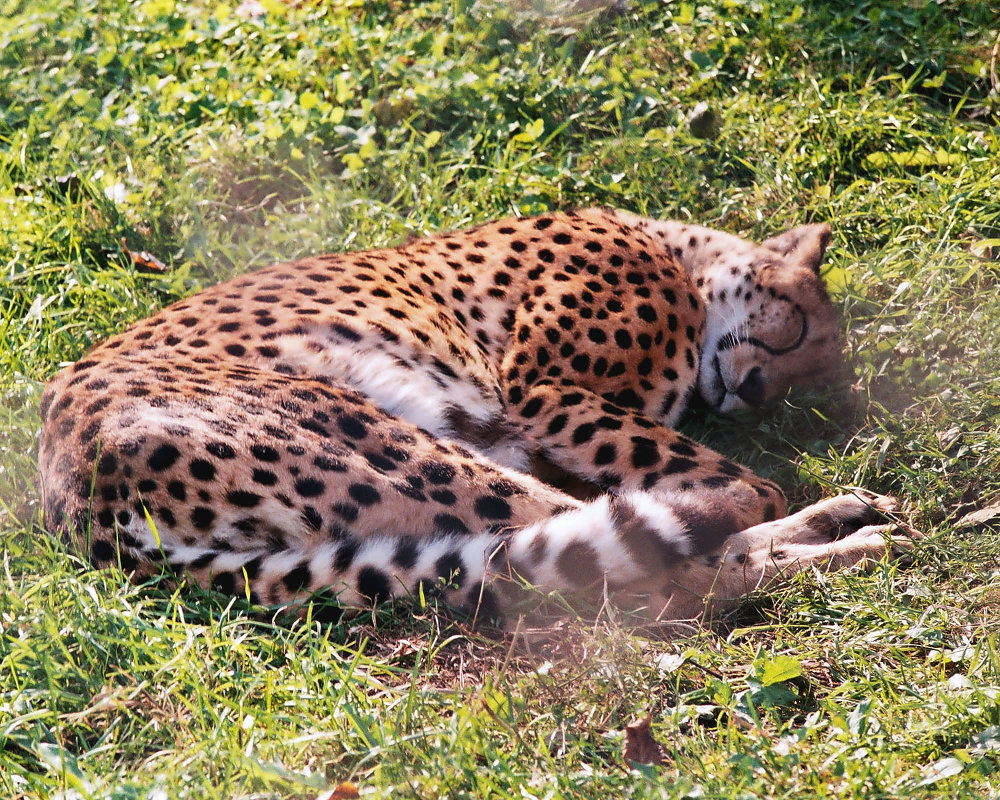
[692,225,840,412]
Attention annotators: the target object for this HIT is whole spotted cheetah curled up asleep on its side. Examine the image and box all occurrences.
[40,209,916,620]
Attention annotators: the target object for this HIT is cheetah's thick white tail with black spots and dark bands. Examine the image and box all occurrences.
[158,492,692,616]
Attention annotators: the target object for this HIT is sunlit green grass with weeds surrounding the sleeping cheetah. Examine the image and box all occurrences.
[0,0,1000,798]
